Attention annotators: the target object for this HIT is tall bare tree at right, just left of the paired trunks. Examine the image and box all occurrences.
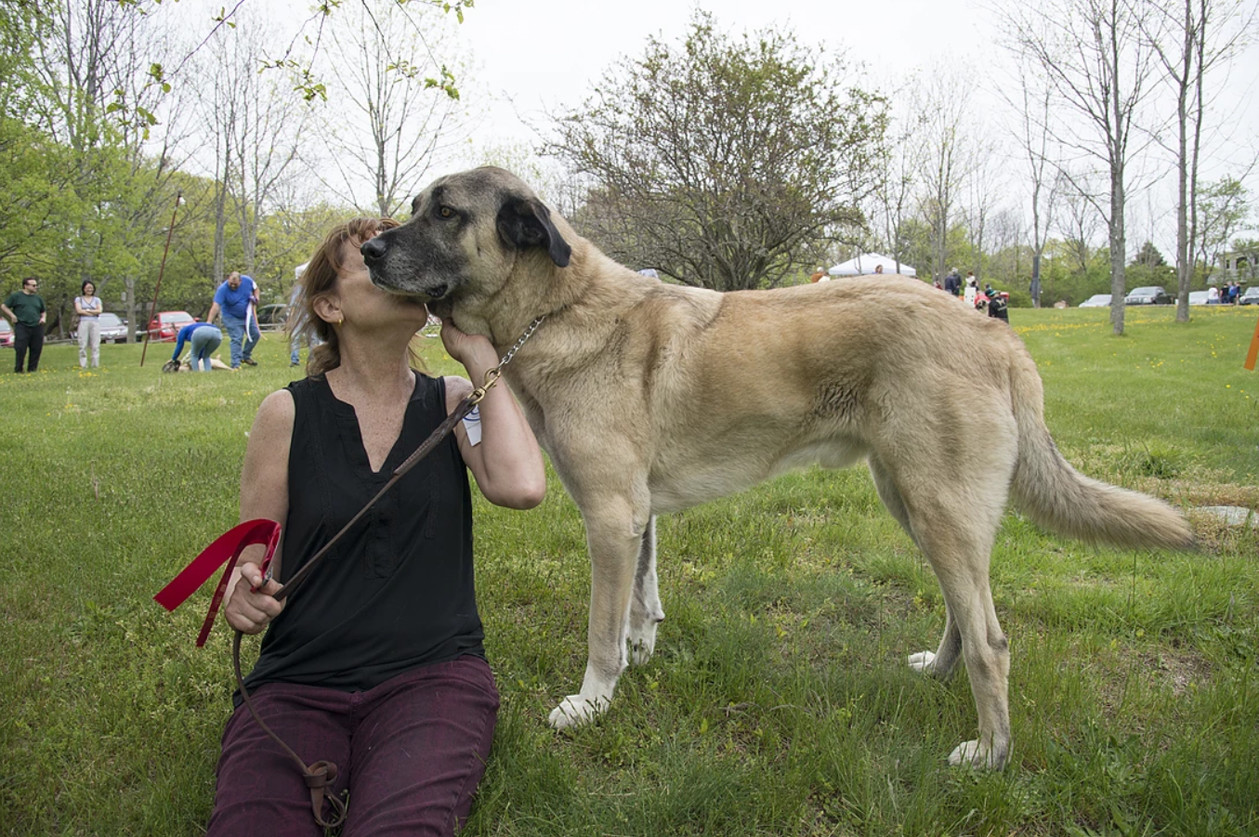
[1006,0,1153,335]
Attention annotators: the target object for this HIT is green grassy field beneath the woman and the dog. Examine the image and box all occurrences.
[0,308,1259,837]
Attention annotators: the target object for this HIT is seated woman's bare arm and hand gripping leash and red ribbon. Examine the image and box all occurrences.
[223,389,293,633]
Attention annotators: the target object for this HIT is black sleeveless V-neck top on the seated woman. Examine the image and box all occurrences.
[246,374,485,691]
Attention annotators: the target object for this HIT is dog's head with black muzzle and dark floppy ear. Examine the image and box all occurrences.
[363,166,572,313]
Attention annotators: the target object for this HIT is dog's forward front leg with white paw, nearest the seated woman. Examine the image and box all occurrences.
[549,497,650,729]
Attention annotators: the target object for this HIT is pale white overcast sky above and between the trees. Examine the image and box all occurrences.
[211,0,1259,247]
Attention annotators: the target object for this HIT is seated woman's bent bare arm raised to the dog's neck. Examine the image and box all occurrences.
[442,318,546,508]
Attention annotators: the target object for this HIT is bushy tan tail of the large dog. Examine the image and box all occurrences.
[1010,352,1194,549]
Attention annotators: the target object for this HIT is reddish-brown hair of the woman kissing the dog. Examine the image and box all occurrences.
[288,218,398,376]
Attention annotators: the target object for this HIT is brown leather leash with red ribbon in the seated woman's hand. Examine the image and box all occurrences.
[154,315,546,828]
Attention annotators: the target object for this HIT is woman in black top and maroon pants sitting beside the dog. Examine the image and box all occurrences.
[209,219,546,837]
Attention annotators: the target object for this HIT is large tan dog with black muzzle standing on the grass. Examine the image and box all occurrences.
[363,169,1192,768]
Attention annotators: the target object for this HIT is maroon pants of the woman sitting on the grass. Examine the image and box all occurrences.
[208,657,499,837]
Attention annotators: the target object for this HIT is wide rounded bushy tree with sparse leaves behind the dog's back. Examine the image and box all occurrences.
[548,13,886,291]
